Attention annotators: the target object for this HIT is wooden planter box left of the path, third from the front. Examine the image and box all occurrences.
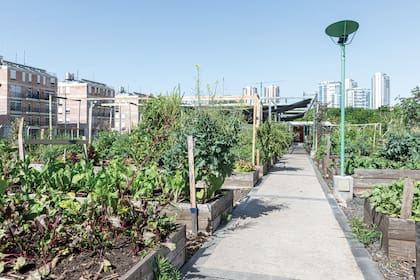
[222,170,259,203]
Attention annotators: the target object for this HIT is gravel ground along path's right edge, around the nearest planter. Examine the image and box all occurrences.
[342,197,416,280]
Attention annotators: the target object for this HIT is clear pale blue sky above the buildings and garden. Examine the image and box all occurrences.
[0,0,420,99]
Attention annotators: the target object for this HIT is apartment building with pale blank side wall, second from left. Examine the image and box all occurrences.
[57,73,115,136]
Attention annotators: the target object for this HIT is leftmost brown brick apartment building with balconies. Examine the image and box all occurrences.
[0,56,57,137]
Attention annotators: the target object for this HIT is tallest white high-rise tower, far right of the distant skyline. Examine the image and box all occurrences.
[371,72,391,109]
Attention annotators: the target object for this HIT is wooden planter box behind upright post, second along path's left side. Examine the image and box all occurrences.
[167,190,233,234]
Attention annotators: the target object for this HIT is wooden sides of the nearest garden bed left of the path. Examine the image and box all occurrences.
[119,225,186,280]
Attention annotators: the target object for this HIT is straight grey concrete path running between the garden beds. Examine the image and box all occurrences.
[182,147,382,280]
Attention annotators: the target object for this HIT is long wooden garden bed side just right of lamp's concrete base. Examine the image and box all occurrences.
[352,169,420,194]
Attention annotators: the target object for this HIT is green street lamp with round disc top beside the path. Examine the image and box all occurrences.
[325,20,359,176]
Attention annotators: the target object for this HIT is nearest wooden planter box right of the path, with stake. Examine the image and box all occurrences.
[364,199,416,262]
